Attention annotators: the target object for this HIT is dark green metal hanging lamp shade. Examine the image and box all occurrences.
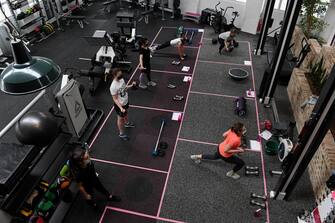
[0,40,61,95]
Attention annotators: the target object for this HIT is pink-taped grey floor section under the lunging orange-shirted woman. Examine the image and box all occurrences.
[161,141,265,223]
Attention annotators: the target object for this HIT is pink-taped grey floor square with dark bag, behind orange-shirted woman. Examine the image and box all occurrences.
[180,94,258,143]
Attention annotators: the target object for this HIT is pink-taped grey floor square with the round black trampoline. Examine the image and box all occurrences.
[191,62,253,96]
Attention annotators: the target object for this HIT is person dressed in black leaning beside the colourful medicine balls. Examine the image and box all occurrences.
[69,146,121,207]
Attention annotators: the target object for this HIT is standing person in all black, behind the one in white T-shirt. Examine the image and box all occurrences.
[139,38,157,89]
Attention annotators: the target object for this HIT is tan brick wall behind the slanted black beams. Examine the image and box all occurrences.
[287,38,335,198]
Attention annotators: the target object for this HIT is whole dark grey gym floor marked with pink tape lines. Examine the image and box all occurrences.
[0,2,314,223]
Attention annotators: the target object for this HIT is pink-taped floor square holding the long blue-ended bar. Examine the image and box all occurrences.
[92,108,180,171]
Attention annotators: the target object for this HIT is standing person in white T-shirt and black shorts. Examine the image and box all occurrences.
[109,68,136,141]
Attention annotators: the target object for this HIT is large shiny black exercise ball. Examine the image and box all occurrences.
[15,111,58,147]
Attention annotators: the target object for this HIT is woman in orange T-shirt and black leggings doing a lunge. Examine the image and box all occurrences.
[191,122,246,180]
